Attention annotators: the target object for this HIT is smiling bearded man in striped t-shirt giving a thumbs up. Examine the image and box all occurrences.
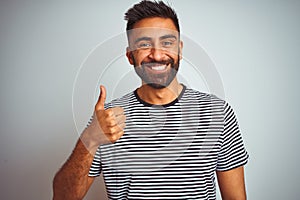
[54,1,248,200]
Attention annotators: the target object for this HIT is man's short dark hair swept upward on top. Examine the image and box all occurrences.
[125,0,180,32]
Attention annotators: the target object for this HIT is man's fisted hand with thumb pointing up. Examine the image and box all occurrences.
[94,86,126,143]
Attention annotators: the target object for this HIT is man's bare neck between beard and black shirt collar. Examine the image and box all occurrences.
[137,78,183,105]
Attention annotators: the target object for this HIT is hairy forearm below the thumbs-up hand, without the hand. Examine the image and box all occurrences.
[53,139,94,200]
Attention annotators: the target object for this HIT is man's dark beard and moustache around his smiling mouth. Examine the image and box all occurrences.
[133,55,180,89]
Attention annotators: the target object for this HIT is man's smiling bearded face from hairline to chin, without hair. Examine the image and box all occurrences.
[126,17,182,89]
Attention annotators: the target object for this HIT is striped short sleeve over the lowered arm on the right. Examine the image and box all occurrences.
[217,102,249,171]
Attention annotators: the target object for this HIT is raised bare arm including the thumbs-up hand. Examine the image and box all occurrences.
[53,87,125,200]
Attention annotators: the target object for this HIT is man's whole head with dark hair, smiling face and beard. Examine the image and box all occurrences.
[125,0,182,89]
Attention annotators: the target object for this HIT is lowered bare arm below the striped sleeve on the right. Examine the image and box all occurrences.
[217,166,247,200]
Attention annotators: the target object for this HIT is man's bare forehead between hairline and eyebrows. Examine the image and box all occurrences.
[128,17,179,40]
